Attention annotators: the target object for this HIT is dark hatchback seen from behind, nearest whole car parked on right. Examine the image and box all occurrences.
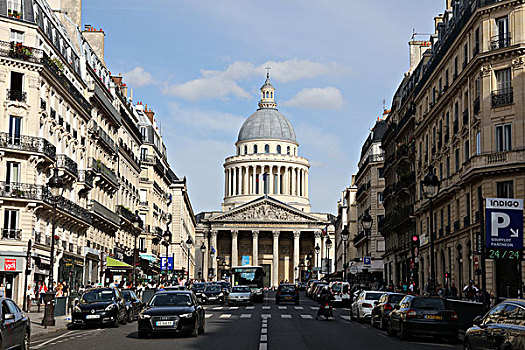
[387,295,459,344]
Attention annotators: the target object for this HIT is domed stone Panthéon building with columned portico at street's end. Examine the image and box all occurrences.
[195,75,336,286]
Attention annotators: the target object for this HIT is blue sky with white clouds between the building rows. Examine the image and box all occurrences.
[83,0,445,213]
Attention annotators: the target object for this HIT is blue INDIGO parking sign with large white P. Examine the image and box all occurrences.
[485,198,523,260]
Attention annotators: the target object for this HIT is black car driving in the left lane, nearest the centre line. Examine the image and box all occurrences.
[138,291,205,338]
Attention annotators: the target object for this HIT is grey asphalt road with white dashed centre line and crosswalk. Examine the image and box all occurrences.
[31,293,461,350]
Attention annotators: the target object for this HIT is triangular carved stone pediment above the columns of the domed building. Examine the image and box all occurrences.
[210,197,323,224]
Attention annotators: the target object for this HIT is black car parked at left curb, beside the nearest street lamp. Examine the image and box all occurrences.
[72,288,128,327]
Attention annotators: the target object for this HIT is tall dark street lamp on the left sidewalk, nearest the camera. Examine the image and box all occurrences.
[43,166,64,328]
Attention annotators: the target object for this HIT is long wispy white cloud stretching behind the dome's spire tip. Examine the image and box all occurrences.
[164,59,349,101]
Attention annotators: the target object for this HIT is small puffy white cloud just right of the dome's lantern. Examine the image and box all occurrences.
[282,86,344,110]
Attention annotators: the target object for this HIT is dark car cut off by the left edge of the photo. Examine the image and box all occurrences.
[0,298,31,349]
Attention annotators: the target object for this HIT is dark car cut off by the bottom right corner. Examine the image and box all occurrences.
[463,299,525,350]
